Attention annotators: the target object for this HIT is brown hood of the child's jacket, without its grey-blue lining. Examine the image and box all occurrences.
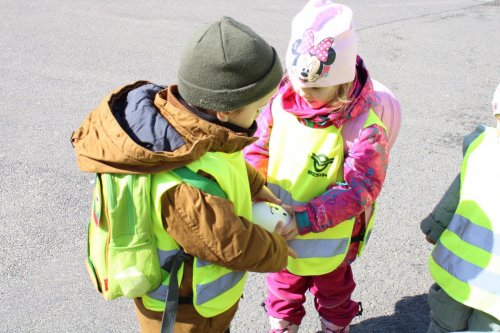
[71,81,256,174]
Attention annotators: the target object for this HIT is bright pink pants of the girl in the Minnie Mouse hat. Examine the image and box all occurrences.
[265,264,359,326]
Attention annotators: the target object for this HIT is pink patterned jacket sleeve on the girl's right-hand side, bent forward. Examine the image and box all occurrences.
[294,125,389,235]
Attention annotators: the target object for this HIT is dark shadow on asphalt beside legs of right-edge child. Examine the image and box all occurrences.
[350,294,430,333]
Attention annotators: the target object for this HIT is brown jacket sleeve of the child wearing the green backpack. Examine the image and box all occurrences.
[162,183,288,272]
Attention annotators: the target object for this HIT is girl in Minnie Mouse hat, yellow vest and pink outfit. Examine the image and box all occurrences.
[244,0,400,332]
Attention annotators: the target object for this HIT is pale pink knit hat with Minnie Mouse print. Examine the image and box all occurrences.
[286,0,358,87]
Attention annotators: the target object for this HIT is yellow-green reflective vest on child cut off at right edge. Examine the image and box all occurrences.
[430,128,500,319]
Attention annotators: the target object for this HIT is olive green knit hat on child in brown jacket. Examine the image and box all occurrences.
[177,16,283,111]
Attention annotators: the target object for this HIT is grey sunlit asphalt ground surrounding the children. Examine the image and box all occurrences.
[0,0,500,333]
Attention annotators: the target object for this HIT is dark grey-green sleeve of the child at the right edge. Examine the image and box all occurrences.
[420,174,460,242]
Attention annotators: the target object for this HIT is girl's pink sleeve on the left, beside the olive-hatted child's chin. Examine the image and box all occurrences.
[243,102,273,180]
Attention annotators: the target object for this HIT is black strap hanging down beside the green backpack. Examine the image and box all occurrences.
[161,250,191,333]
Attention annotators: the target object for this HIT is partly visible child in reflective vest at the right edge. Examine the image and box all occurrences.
[420,85,500,333]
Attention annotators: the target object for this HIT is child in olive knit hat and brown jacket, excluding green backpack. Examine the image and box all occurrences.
[72,17,294,332]
